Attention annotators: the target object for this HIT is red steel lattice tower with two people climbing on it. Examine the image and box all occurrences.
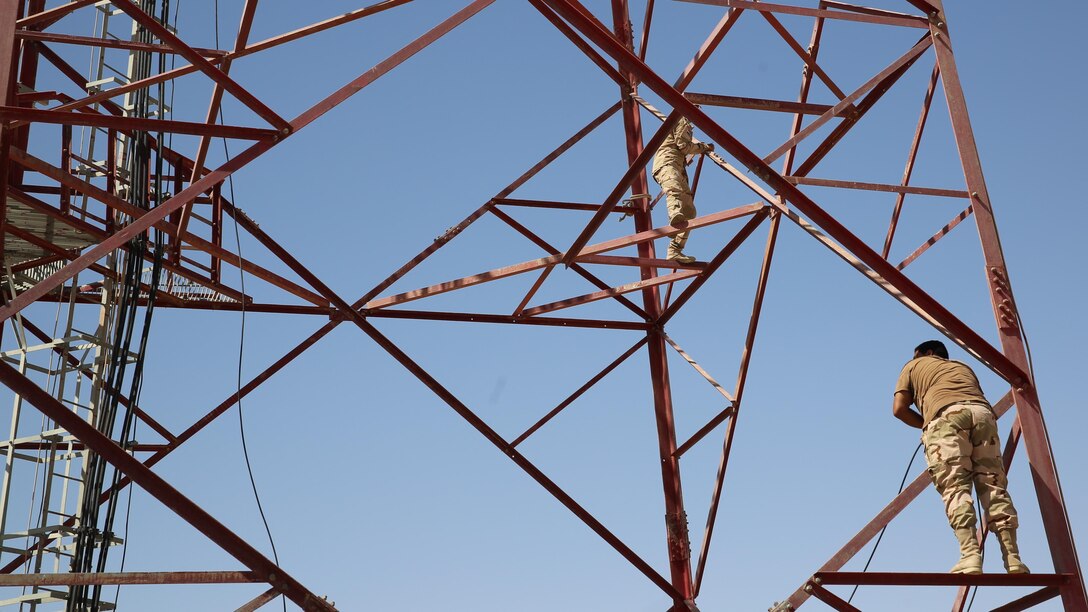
[0,0,1088,611]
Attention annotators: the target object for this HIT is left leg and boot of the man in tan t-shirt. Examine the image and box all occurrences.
[923,406,982,574]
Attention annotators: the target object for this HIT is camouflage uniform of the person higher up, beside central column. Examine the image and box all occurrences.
[653,118,712,256]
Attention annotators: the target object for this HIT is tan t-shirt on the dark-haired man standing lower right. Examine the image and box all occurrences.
[895,355,989,424]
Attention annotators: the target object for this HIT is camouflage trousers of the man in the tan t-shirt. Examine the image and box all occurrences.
[922,404,1017,531]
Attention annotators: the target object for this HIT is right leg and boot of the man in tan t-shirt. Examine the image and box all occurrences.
[970,406,1028,574]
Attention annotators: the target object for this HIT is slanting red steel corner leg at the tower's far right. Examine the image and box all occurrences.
[929,0,1088,612]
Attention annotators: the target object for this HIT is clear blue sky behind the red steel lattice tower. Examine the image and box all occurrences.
[17,0,1088,612]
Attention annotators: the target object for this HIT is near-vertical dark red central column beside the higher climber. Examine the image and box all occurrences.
[611,0,694,609]
